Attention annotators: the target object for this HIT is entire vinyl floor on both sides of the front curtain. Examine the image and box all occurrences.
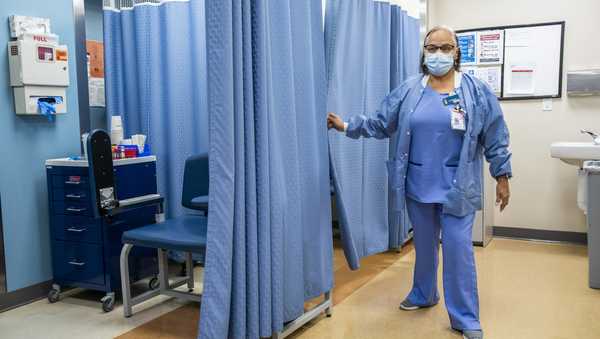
[0,238,600,339]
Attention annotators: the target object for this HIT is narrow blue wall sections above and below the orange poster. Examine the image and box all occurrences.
[85,0,108,130]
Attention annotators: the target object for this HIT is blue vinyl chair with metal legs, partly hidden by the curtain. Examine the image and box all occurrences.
[120,154,209,317]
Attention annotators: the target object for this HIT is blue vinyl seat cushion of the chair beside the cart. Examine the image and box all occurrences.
[122,215,207,253]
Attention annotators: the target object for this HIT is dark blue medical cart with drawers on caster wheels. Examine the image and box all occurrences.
[46,156,158,312]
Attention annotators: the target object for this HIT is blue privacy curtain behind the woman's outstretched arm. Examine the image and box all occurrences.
[325,0,420,269]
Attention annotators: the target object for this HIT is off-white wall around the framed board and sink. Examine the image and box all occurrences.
[429,0,600,232]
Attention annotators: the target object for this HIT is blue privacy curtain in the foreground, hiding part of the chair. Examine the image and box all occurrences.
[199,0,332,338]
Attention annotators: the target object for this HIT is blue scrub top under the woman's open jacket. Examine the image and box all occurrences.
[406,86,464,204]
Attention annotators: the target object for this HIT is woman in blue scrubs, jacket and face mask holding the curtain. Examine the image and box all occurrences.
[327,26,512,339]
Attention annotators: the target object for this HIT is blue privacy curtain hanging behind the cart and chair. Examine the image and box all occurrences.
[104,0,208,216]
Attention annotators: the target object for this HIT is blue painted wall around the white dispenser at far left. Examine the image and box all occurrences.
[0,0,79,291]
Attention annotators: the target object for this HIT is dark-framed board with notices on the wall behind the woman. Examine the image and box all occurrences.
[457,21,565,100]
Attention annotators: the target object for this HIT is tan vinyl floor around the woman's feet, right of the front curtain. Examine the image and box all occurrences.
[296,239,600,339]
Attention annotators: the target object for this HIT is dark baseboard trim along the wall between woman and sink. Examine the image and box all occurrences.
[494,226,587,245]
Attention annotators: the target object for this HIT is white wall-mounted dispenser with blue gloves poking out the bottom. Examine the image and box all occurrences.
[8,16,69,115]
